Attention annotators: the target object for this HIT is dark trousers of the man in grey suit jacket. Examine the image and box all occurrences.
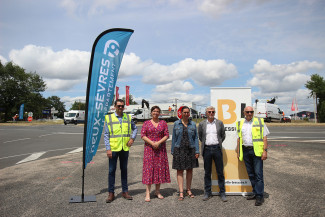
[203,145,226,194]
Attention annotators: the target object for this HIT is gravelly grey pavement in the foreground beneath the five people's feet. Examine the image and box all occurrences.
[0,126,325,216]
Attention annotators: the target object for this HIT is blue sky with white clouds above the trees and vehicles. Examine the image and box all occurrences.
[0,0,325,115]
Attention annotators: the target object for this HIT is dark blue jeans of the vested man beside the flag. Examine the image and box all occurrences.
[108,150,129,193]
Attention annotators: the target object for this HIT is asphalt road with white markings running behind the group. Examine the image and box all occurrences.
[0,124,325,169]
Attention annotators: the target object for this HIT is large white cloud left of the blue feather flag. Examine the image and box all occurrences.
[9,45,90,90]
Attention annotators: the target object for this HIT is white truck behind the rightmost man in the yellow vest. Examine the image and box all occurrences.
[253,98,283,123]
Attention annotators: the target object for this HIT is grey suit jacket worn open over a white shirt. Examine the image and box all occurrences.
[198,119,226,156]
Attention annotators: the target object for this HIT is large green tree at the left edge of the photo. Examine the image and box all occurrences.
[0,62,46,121]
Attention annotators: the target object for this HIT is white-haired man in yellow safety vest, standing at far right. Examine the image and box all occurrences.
[237,106,270,206]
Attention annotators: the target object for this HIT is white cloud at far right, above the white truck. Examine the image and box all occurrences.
[247,59,324,93]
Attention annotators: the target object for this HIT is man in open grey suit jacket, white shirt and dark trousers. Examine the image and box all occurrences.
[198,106,227,202]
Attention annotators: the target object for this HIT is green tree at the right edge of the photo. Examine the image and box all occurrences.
[305,74,325,122]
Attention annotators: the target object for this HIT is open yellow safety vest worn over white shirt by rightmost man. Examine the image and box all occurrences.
[237,118,264,161]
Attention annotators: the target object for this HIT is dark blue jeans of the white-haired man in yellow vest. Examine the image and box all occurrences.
[243,147,264,198]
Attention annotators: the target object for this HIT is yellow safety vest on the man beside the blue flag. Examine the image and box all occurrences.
[105,113,132,152]
